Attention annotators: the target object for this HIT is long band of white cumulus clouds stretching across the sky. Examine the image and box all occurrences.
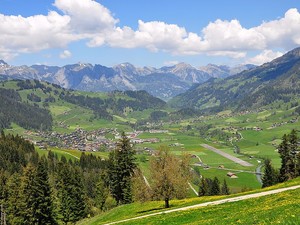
[0,0,300,62]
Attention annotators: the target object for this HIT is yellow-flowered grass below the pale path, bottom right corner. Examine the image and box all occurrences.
[122,190,300,225]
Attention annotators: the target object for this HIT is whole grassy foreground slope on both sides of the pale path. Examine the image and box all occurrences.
[78,178,300,225]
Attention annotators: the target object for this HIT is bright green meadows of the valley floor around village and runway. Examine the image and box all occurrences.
[27,104,299,193]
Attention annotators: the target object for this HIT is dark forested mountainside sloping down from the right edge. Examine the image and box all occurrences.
[170,48,300,112]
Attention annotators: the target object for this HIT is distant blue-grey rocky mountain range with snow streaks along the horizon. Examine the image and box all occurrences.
[0,60,255,100]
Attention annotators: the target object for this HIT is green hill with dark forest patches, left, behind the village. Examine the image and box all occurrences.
[0,80,166,130]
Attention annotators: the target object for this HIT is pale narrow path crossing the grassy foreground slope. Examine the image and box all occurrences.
[106,185,300,225]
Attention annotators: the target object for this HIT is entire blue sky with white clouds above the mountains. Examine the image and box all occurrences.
[0,0,300,68]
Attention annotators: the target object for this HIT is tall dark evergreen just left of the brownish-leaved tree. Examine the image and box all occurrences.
[108,132,136,204]
